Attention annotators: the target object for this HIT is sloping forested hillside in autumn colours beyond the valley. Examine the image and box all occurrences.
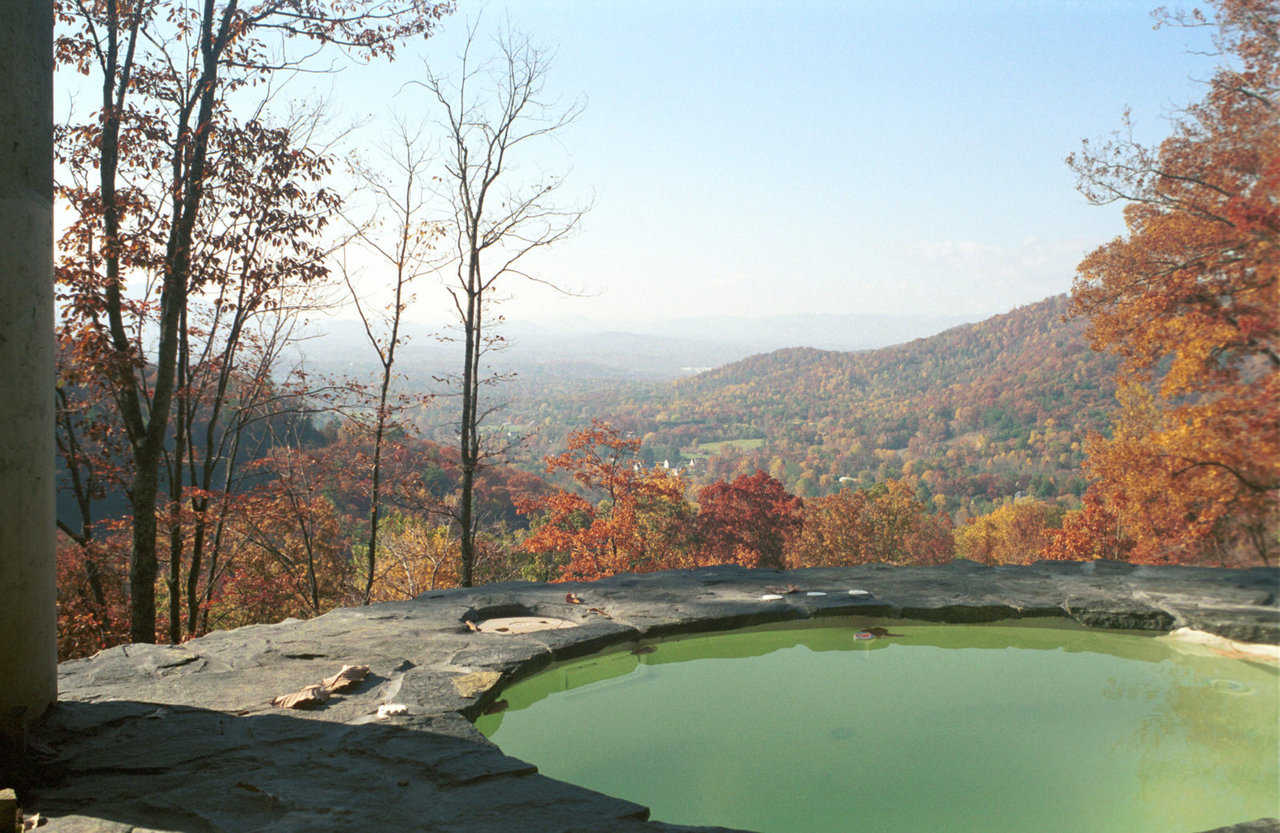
[504,296,1115,513]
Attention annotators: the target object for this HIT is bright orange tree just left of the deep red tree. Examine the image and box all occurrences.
[516,420,692,581]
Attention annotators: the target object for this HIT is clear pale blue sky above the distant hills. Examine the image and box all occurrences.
[194,0,1233,326]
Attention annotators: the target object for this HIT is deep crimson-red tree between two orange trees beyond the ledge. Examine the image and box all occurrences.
[698,470,804,569]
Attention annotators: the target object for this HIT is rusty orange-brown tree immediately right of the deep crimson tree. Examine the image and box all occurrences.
[787,480,952,567]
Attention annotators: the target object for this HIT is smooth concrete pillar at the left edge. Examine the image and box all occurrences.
[0,0,58,731]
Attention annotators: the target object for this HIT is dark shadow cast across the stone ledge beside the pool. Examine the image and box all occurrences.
[29,700,648,833]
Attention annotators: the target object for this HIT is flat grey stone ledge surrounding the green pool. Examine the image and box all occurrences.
[27,560,1280,833]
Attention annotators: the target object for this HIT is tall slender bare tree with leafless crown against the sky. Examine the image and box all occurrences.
[420,27,582,587]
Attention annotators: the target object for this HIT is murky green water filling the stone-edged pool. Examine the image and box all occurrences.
[476,619,1280,833]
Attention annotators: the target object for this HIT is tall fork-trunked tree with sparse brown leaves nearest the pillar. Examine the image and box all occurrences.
[55,0,448,642]
